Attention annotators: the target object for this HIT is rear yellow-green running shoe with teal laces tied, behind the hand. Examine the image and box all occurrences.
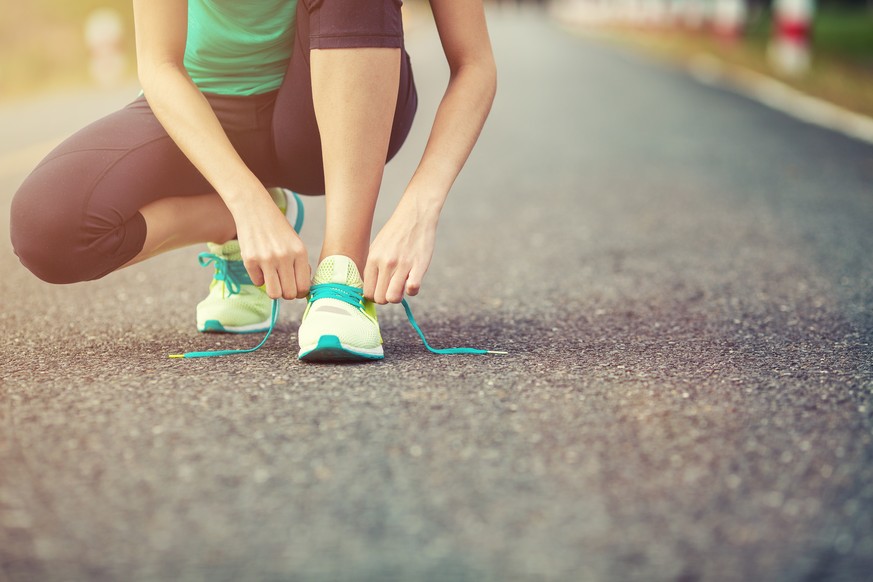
[197,188,303,333]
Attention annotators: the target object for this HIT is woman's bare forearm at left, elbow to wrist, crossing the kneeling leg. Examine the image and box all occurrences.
[140,63,263,212]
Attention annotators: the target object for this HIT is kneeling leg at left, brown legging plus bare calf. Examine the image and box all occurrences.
[11,95,275,283]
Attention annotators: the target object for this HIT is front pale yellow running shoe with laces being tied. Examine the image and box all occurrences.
[297,255,384,362]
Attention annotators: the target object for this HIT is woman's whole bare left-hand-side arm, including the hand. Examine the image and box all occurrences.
[133,0,309,299]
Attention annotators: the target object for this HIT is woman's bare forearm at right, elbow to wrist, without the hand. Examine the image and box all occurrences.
[401,58,497,221]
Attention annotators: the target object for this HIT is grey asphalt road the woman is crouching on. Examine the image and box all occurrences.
[0,5,873,582]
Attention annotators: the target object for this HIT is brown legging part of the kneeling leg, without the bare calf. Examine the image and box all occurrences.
[11,94,275,282]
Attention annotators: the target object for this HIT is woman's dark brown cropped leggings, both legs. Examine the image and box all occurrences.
[10,0,417,283]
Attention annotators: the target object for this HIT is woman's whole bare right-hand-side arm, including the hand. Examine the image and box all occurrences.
[356,0,497,303]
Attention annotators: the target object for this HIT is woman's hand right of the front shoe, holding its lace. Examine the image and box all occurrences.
[364,201,439,305]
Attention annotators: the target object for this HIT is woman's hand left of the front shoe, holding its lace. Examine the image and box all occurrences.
[231,191,310,299]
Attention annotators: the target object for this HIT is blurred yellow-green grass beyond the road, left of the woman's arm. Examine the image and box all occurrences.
[0,0,134,99]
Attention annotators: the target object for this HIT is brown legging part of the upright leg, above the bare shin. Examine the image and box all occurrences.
[273,0,418,194]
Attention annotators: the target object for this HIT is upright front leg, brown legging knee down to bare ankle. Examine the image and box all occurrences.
[274,0,417,269]
